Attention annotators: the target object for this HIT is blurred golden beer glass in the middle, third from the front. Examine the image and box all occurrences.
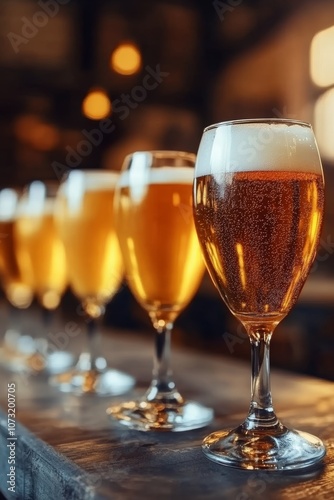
[51,170,134,396]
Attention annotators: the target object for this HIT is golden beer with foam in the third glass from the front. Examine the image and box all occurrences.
[56,171,123,304]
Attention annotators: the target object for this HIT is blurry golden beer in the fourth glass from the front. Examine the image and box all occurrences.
[15,199,67,309]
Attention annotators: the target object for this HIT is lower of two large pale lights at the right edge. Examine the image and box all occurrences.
[314,88,334,160]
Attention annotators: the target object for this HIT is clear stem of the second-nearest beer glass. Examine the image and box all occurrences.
[146,321,183,405]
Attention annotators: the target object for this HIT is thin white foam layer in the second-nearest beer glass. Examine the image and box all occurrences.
[119,166,194,187]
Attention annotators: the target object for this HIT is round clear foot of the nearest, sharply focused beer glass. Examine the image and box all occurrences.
[202,426,326,471]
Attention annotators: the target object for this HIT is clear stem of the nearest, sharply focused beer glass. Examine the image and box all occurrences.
[243,326,281,430]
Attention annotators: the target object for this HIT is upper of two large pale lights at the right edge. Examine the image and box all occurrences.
[310,26,334,87]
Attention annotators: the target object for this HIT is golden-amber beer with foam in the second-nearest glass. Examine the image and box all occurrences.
[117,167,204,313]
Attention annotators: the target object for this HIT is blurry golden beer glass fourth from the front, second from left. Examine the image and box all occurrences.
[14,181,73,373]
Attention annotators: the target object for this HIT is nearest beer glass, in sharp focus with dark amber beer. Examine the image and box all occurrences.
[194,119,325,470]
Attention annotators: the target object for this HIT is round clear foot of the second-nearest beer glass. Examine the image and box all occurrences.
[107,400,213,432]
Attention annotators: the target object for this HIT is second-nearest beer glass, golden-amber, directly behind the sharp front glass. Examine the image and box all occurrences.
[107,151,212,431]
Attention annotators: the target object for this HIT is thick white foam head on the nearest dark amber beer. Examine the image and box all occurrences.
[195,120,320,177]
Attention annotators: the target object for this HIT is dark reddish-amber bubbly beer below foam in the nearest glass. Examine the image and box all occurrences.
[194,169,324,320]
